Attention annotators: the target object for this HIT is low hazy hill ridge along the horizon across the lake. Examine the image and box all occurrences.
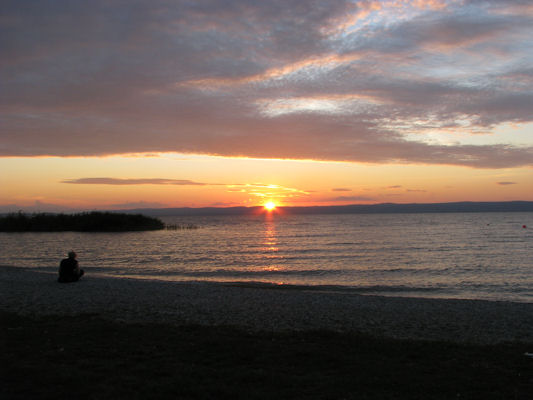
[120,201,533,217]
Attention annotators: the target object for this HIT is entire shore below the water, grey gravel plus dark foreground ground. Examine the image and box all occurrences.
[0,267,533,400]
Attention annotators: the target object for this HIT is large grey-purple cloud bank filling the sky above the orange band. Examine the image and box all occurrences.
[0,0,533,167]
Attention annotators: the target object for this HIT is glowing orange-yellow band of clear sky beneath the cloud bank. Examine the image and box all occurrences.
[0,153,533,211]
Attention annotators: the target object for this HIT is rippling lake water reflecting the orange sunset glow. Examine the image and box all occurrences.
[0,213,533,302]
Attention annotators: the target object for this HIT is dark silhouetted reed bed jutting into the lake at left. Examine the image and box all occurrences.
[0,211,165,232]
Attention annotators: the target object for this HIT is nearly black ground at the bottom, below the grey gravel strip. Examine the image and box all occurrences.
[0,312,533,400]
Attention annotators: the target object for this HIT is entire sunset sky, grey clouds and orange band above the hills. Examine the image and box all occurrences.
[0,0,533,212]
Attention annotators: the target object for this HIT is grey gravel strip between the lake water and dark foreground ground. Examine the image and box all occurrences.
[0,266,533,344]
